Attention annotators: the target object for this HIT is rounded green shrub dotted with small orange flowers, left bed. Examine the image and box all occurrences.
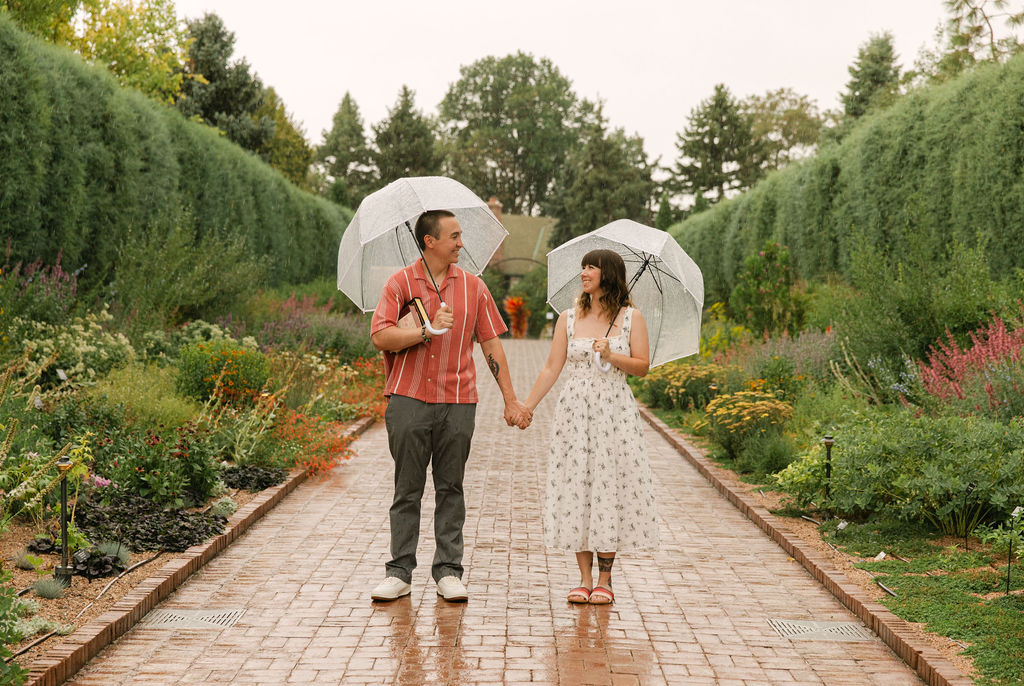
[176,339,270,406]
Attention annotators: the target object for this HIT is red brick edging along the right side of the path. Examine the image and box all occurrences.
[638,403,974,686]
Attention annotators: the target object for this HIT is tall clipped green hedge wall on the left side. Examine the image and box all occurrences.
[0,13,351,284]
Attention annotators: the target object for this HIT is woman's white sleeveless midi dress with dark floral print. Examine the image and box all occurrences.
[544,307,657,553]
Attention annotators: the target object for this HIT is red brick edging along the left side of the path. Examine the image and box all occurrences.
[27,417,375,686]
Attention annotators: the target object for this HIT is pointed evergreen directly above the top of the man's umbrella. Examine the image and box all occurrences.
[370,86,442,185]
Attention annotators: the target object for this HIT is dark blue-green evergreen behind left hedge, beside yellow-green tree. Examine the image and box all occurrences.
[176,13,274,159]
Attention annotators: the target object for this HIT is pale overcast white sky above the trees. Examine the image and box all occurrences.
[175,0,945,165]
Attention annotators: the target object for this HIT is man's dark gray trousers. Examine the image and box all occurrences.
[384,395,476,584]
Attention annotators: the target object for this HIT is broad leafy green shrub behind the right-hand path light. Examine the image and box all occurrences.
[778,410,1024,535]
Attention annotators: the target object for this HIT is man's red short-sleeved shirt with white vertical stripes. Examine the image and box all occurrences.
[370,260,508,403]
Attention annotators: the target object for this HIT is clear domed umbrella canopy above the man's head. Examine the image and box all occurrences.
[338,176,508,312]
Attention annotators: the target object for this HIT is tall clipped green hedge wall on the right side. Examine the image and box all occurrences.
[670,56,1024,302]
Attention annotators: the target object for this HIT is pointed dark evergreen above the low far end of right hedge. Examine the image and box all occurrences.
[674,84,763,203]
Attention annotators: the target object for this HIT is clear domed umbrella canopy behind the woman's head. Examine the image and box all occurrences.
[548,219,703,367]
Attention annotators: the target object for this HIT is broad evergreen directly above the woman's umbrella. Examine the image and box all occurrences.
[543,115,655,245]
